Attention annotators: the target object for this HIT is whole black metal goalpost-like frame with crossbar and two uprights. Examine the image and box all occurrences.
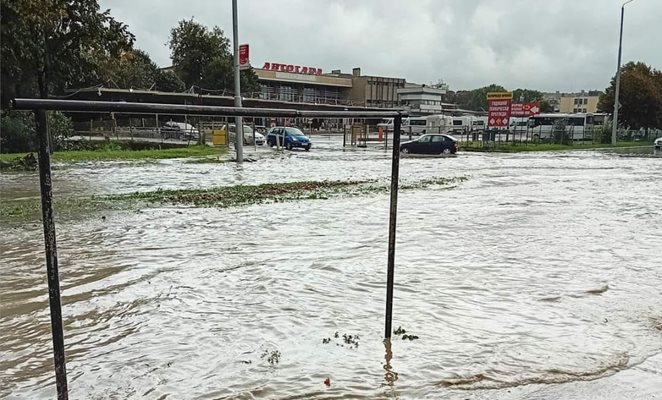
[11,98,407,400]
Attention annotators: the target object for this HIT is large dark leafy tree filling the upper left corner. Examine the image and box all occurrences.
[0,0,134,104]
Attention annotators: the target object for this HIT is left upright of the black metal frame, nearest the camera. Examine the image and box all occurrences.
[35,110,69,400]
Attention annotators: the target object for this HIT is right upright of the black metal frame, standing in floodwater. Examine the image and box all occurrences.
[384,115,402,339]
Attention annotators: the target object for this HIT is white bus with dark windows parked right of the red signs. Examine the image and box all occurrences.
[529,113,607,140]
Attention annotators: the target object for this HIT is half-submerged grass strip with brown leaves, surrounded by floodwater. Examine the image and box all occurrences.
[0,177,466,221]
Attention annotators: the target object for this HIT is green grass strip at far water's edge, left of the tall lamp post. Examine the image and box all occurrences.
[0,144,227,162]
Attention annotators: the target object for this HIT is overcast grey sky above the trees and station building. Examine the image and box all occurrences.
[100,0,662,91]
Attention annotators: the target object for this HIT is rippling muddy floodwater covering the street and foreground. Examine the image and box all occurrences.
[0,142,662,399]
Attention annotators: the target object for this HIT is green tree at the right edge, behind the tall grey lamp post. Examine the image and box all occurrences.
[598,62,662,129]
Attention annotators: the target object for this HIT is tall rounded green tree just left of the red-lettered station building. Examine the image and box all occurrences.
[169,19,260,93]
